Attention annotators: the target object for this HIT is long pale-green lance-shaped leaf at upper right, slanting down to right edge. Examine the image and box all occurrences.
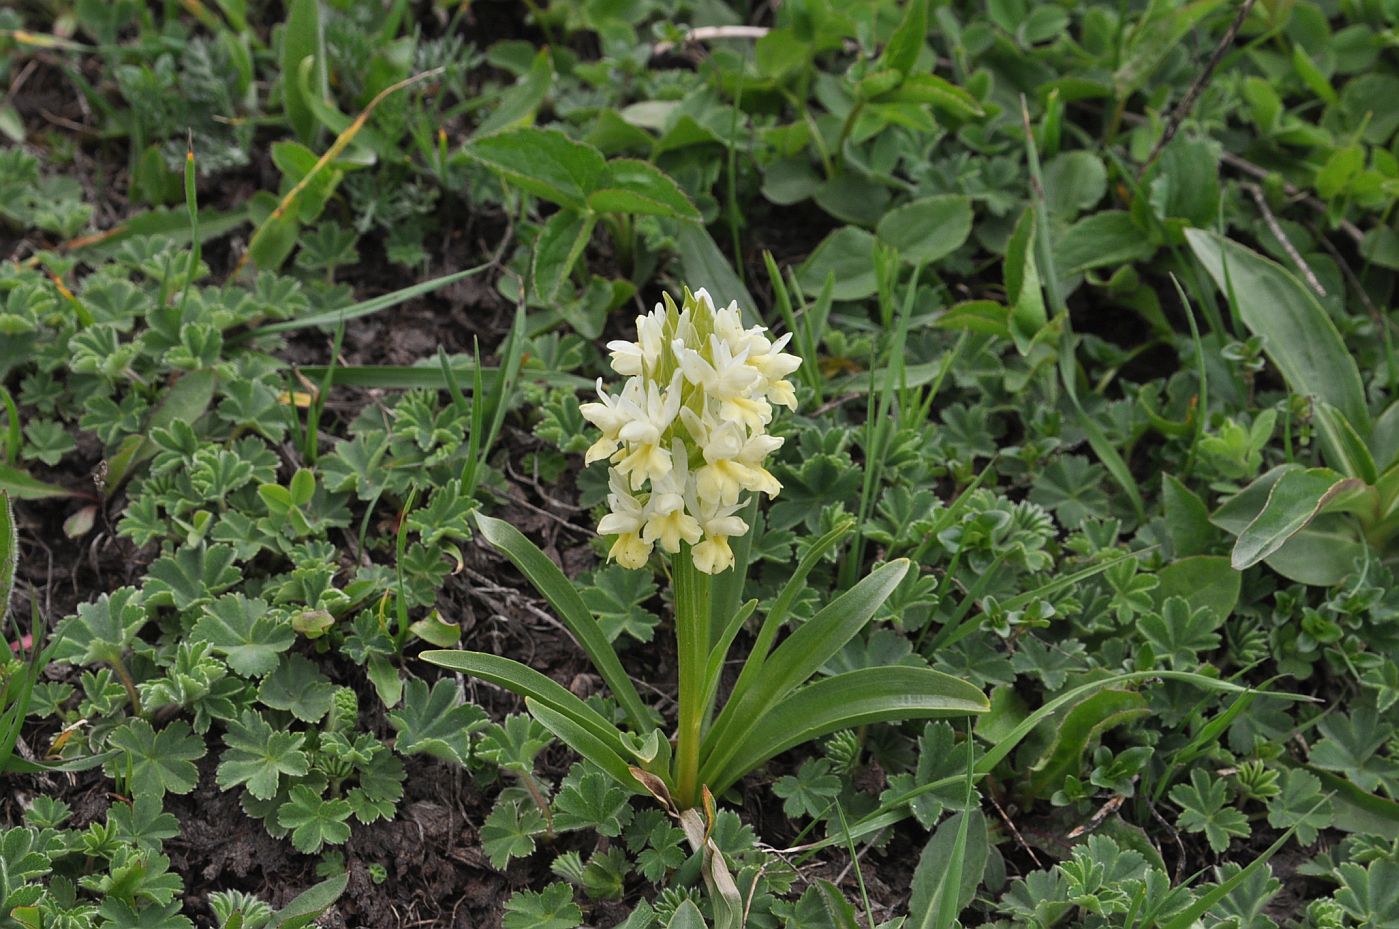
[1185,229,1370,436]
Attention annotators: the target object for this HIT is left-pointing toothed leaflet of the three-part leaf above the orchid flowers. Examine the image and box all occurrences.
[463,127,607,210]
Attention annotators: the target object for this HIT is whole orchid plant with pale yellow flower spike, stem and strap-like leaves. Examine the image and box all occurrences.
[424,290,988,813]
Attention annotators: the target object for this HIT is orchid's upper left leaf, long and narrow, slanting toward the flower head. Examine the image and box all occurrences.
[476,513,652,732]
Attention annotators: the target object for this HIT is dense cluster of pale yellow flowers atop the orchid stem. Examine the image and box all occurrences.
[582,288,802,574]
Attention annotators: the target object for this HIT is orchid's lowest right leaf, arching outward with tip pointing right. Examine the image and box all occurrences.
[701,667,989,793]
